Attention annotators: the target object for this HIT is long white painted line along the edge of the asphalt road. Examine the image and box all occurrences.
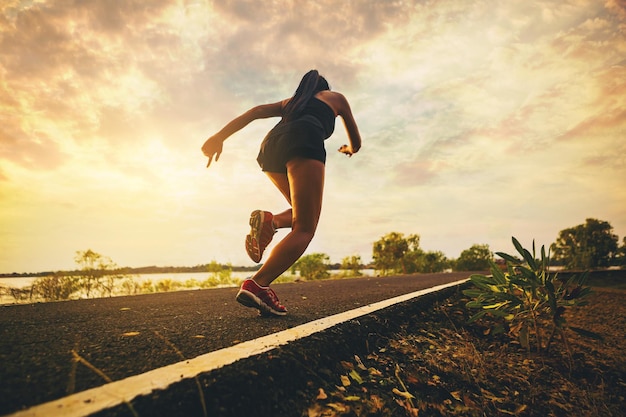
[6,279,467,417]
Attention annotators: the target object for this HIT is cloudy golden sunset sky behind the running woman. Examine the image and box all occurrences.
[0,0,626,273]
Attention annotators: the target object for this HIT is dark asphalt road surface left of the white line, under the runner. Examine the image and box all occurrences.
[0,272,470,415]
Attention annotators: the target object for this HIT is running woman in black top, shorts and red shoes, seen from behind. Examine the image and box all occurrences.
[202,70,361,316]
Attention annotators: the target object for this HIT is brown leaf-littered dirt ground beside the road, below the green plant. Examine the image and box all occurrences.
[301,289,626,417]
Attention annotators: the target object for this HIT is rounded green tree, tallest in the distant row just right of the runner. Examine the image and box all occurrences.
[372,232,423,275]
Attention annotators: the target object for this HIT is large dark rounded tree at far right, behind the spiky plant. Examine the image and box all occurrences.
[550,219,618,269]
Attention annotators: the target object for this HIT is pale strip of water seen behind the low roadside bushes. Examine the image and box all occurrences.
[0,269,375,305]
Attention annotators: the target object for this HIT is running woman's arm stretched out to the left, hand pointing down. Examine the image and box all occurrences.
[202,100,285,168]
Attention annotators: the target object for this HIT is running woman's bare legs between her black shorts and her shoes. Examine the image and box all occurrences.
[253,158,325,286]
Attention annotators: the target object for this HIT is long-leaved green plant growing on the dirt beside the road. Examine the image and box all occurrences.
[463,237,591,359]
